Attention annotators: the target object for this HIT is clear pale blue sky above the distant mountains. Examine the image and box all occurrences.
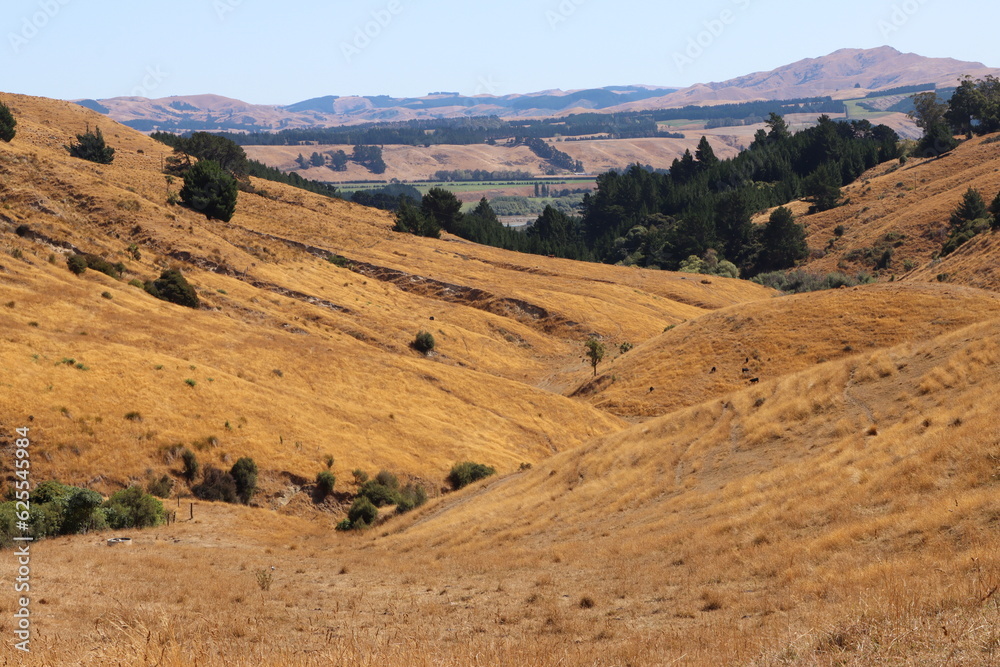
[0,0,1000,104]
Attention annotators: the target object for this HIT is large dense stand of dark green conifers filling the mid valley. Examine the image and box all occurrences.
[397,113,900,276]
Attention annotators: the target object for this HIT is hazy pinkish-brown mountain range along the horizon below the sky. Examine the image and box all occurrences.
[78,46,1000,131]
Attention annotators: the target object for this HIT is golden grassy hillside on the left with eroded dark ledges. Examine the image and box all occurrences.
[0,92,769,490]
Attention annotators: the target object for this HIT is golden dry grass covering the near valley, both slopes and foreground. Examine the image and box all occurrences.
[0,92,1000,665]
